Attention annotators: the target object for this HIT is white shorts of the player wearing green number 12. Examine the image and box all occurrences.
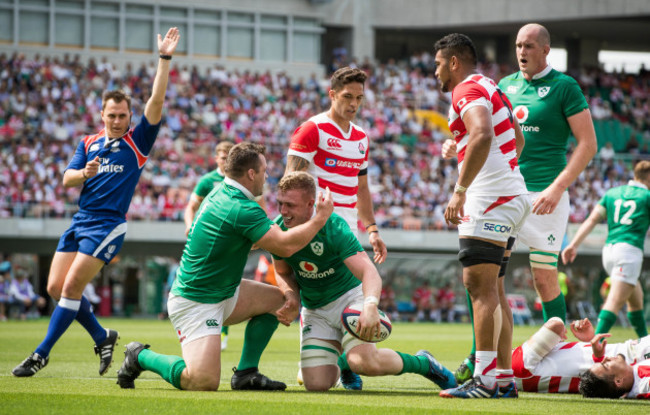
[603,242,643,285]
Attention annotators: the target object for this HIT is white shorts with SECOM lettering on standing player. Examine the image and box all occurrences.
[458,195,531,242]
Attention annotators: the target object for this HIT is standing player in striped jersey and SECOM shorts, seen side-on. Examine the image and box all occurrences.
[434,33,531,398]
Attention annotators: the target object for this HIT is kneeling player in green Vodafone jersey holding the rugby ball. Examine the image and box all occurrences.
[273,172,456,391]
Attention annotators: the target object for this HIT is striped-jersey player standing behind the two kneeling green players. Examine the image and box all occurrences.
[285,67,386,264]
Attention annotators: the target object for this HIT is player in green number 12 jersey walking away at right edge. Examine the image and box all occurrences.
[562,160,650,337]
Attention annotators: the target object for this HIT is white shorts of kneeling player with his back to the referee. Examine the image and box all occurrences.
[167,287,239,347]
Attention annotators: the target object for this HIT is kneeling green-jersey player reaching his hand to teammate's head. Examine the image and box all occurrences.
[117,143,334,391]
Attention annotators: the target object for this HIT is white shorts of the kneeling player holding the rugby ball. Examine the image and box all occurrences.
[300,285,372,352]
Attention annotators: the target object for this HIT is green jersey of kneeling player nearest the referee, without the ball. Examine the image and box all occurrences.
[171,178,273,303]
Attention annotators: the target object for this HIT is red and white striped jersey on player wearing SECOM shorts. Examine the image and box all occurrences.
[448,74,528,196]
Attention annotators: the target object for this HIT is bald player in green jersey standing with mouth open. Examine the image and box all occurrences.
[443,24,597,383]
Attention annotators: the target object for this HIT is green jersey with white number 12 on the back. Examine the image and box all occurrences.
[598,180,650,250]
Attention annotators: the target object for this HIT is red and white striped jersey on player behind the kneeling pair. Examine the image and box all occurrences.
[288,113,369,230]
